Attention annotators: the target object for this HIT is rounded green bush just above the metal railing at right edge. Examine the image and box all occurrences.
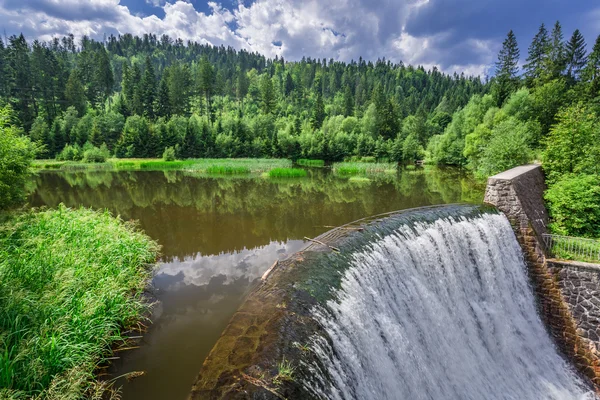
[545,174,600,237]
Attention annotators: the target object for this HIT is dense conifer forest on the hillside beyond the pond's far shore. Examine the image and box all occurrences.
[0,34,489,161]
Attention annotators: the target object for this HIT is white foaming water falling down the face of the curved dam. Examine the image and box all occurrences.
[305,214,595,400]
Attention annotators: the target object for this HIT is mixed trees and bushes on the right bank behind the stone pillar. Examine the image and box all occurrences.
[427,22,600,237]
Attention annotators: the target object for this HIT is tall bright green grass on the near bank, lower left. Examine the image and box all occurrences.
[0,206,158,399]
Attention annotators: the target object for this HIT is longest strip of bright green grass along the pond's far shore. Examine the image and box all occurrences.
[33,158,292,175]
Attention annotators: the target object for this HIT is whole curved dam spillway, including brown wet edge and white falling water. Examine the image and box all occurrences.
[192,206,595,400]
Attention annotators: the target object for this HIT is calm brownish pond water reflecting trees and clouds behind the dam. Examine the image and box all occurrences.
[30,169,483,400]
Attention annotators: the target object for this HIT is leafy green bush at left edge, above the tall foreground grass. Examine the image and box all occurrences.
[0,107,38,210]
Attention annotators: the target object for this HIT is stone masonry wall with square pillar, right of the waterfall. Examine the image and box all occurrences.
[484,165,600,392]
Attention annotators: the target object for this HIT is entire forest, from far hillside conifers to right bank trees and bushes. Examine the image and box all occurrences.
[0,21,600,236]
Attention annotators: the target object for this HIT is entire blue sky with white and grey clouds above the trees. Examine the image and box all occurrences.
[0,0,600,77]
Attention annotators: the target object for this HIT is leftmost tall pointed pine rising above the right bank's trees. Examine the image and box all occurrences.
[494,30,519,106]
